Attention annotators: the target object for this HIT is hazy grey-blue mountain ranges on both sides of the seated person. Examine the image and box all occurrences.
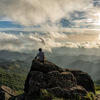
[0,48,100,81]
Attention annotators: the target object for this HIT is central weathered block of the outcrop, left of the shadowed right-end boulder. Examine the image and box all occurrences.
[47,71,77,88]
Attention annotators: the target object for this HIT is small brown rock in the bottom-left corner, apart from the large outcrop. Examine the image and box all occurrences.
[0,85,18,100]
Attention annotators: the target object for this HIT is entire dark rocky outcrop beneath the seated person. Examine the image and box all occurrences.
[9,60,95,100]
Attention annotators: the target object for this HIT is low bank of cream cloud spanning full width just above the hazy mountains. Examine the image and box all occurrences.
[0,32,100,51]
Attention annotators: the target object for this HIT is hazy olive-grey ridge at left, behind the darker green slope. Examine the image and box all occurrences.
[0,59,30,74]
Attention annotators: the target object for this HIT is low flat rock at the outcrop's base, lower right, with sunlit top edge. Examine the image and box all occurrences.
[47,86,87,100]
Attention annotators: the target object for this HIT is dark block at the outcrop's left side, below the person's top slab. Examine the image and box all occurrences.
[24,71,46,92]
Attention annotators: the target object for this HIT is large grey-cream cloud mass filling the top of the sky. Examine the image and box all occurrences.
[0,0,91,26]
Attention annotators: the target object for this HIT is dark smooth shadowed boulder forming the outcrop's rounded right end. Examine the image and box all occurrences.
[66,69,95,94]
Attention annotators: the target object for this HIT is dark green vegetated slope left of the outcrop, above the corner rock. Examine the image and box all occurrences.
[0,67,26,93]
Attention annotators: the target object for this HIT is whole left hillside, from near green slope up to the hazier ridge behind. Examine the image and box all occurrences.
[0,59,30,92]
